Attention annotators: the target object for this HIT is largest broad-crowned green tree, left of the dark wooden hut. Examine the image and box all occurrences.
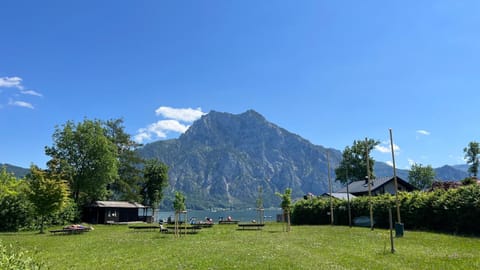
[45,119,118,205]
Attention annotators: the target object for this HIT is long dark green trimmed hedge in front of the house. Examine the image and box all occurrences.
[292,185,480,235]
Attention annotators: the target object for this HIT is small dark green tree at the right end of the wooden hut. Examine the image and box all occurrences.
[141,159,168,210]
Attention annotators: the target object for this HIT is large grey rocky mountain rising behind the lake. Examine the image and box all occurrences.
[139,110,341,209]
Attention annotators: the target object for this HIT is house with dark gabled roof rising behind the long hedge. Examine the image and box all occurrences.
[336,176,417,196]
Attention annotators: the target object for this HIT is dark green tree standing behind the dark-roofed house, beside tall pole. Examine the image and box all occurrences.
[335,139,380,184]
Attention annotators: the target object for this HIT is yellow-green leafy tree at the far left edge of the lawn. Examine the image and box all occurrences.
[0,167,31,231]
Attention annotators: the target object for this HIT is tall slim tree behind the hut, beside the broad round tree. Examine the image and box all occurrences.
[104,119,144,201]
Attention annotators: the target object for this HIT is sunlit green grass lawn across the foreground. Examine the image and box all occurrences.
[0,223,480,270]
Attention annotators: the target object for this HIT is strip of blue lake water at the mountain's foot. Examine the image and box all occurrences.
[155,209,282,223]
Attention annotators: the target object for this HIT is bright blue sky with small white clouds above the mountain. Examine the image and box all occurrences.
[0,0,480,171]
